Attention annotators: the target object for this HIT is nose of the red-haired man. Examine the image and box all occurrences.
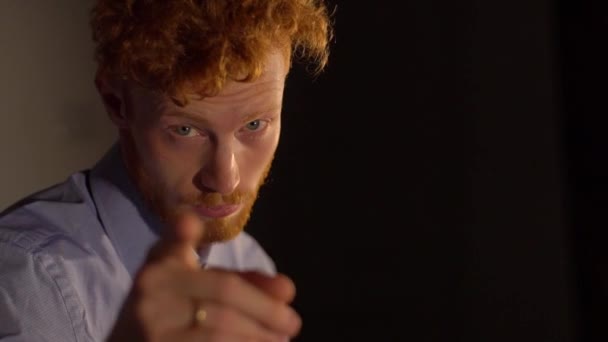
[200,144,240,195]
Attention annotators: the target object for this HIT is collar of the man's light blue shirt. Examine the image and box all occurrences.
[90,143,210,276]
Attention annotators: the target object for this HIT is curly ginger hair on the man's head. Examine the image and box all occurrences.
[90,0,332,105]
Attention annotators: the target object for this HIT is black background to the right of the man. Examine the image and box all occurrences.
[248,0,608,342]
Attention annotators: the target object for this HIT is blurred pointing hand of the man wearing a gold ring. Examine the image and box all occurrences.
[108,212,301,342]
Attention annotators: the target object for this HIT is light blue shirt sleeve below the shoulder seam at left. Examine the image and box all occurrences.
[0,241,84,342]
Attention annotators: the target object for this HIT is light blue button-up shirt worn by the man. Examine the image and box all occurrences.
[0,145,276,342]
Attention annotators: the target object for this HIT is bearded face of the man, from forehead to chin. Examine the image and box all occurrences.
[121,54,287,243]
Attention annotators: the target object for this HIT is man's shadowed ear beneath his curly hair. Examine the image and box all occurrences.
[95,70,128,129]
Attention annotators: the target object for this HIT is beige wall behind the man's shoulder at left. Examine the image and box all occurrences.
[0,0,115,209]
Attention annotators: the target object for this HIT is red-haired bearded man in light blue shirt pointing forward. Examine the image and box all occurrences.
[0,0,331,342]
